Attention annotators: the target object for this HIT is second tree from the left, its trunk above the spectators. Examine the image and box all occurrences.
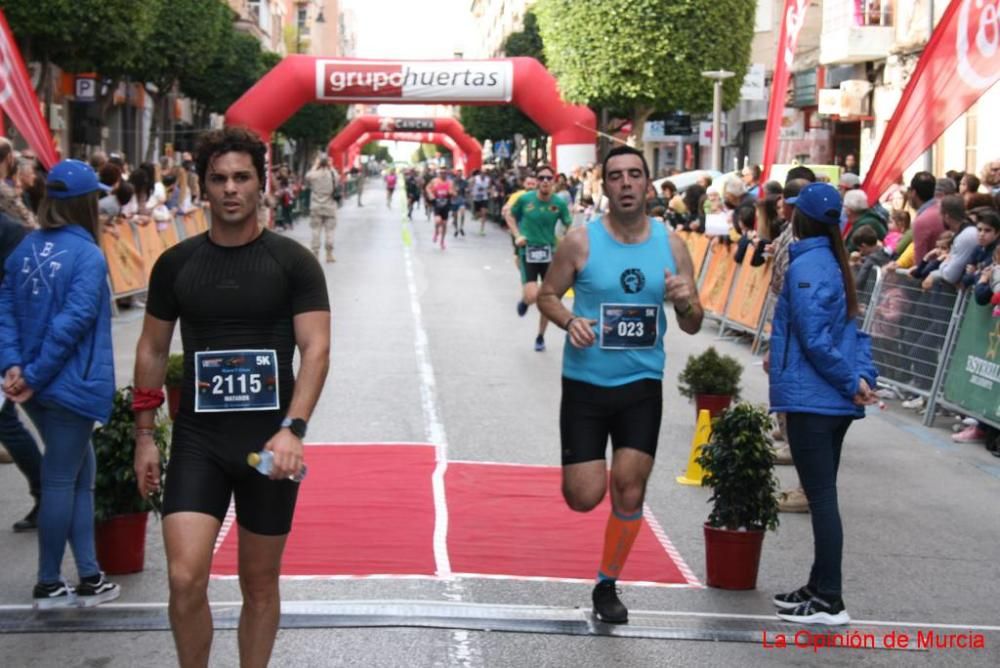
[133,0,236,161]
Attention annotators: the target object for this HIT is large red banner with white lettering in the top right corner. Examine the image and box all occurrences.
[864,0,1000,201]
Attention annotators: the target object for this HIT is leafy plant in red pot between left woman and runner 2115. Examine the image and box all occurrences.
[91,387,168,574]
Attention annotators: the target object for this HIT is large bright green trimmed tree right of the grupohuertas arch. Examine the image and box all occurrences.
[535,0,756,146]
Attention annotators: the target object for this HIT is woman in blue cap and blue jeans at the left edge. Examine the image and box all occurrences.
[0,160,120,608]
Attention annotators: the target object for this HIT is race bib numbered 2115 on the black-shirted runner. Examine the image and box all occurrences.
[194,350,281,413]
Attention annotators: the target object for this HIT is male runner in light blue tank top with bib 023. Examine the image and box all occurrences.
[538,146,704,624]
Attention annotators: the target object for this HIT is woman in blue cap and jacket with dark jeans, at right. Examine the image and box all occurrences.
[768,183,878,624]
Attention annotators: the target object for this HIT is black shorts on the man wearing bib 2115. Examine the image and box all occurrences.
[163,415,299,536]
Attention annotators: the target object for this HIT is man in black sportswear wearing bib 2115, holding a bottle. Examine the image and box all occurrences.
[129,128,330,666]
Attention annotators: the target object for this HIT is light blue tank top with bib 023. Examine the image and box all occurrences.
[563,218,677,387]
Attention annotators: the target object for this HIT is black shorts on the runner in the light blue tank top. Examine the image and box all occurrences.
[559,377,663,466]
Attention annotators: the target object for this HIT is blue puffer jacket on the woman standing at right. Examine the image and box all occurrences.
[770,237,878,417]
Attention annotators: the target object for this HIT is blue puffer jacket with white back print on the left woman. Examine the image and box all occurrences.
[0,225,115,423]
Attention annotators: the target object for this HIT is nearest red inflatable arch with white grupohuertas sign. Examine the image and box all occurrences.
[226,55,597,173]
